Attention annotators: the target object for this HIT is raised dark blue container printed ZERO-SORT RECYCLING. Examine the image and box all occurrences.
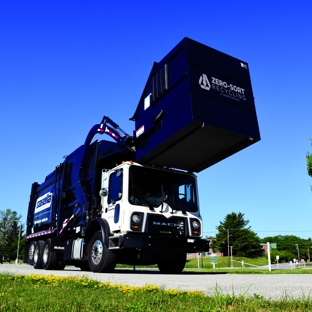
[131,38,260,172]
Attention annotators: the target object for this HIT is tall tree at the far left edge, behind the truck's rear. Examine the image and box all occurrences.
[0,209,24,260]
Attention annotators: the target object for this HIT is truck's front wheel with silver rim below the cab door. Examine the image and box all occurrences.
[88,231,116,273]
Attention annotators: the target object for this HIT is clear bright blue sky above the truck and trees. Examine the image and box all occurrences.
[0,0,312,238]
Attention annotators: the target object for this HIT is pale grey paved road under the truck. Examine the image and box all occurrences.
[0,264,312,300]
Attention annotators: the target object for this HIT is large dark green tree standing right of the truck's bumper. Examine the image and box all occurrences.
[211,212,262,257]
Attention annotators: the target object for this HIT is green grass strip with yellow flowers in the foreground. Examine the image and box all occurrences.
[0,274,312,312]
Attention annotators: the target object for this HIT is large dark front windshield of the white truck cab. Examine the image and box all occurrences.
[129,166,198,212]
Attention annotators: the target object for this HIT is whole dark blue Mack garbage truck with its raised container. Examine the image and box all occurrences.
[24,38,260,274]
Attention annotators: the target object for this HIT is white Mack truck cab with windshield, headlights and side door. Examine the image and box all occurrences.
[100,161,202,238]
